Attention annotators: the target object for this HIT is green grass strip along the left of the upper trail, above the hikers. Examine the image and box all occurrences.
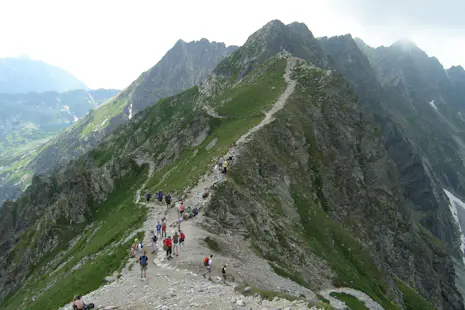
[148,59,286,191]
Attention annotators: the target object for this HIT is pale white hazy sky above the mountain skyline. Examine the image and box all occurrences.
[0,0,465,88]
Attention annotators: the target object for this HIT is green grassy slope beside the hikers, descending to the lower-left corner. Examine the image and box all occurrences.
[2,166,146,309]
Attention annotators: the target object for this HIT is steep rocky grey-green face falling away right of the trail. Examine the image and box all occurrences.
[208,59,462,309]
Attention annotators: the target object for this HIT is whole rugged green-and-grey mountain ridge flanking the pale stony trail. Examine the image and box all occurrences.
[0,21,465,310]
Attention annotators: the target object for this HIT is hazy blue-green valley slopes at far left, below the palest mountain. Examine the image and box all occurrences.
[0,89,118,202]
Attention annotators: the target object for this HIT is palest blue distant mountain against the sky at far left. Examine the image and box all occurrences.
[0,57,88,93]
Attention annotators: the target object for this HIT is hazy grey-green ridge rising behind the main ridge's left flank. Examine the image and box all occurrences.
[0,39,237,201]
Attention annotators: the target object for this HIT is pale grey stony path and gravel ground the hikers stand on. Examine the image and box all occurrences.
[62,58,382,310]
